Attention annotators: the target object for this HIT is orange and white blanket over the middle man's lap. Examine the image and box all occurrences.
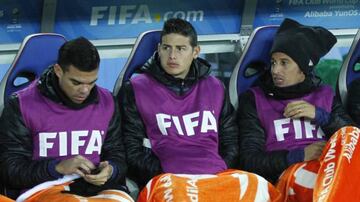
[138,170,280,202]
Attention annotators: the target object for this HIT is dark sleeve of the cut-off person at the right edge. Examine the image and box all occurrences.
[347,79,360,127]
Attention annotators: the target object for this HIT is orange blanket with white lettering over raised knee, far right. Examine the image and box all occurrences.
[314,127,360,201]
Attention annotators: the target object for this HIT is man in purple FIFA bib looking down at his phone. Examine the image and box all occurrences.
[0,37,132,201]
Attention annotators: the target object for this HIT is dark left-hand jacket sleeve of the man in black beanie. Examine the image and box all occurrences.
[238,91,289,182]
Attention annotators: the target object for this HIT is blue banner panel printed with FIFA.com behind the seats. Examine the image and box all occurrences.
[55,0,244,40]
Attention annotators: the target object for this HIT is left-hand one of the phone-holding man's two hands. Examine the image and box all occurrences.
[55,155,95,177]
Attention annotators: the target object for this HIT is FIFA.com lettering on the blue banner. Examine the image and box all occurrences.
[90,4,204,26]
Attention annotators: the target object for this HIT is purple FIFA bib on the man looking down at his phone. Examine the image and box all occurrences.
[18,81,114,164]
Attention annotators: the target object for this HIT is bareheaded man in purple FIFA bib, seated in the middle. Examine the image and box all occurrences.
[119,19,238,186]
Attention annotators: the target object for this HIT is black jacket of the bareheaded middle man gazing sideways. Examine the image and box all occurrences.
[118,54,238,187]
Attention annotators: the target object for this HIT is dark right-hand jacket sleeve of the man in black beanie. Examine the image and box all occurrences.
[321,95,354,138]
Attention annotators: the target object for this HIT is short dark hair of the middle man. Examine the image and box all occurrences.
[160,18,197,47]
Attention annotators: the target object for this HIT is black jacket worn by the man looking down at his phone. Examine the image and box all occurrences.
[0,68,127,194]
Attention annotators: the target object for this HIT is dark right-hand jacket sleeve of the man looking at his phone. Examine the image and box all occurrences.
[100,96,127,184]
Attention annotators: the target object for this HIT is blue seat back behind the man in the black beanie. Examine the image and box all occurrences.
[229,25,279,109]
